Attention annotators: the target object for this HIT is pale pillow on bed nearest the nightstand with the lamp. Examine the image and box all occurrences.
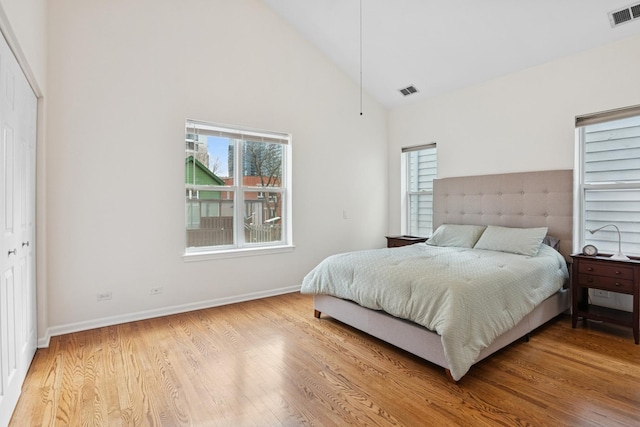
[474,225,547,256]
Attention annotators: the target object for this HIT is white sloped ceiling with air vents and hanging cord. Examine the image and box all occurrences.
[263,0,640,108]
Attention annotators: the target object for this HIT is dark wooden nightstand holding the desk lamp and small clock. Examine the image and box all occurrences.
[571,254,640,344]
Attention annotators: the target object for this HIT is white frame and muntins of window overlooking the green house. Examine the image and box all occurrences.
[182,118,294,261]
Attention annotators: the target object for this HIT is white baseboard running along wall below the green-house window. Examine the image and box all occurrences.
[38,285,300,348]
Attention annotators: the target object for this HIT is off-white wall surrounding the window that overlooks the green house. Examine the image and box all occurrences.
[41,0,388,338]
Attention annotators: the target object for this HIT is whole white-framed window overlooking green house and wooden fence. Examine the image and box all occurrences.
[185,120,291,254]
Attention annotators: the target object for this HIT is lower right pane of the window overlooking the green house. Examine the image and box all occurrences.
[244,191,282,243]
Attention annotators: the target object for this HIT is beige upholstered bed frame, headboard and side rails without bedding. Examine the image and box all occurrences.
[314,170,573,382]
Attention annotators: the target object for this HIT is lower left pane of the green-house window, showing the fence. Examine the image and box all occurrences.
[187,191,234,248]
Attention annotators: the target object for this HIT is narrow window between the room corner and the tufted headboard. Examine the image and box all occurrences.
[402,143,437,237]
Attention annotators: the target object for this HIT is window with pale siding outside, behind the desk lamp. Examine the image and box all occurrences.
[574,107,640,255]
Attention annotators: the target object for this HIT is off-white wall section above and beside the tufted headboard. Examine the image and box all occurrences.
[388,37,640,233]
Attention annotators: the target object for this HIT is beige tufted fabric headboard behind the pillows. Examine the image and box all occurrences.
[433,170,573,259]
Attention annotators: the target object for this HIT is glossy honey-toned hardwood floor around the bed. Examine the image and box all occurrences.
[10,293,640,427]
